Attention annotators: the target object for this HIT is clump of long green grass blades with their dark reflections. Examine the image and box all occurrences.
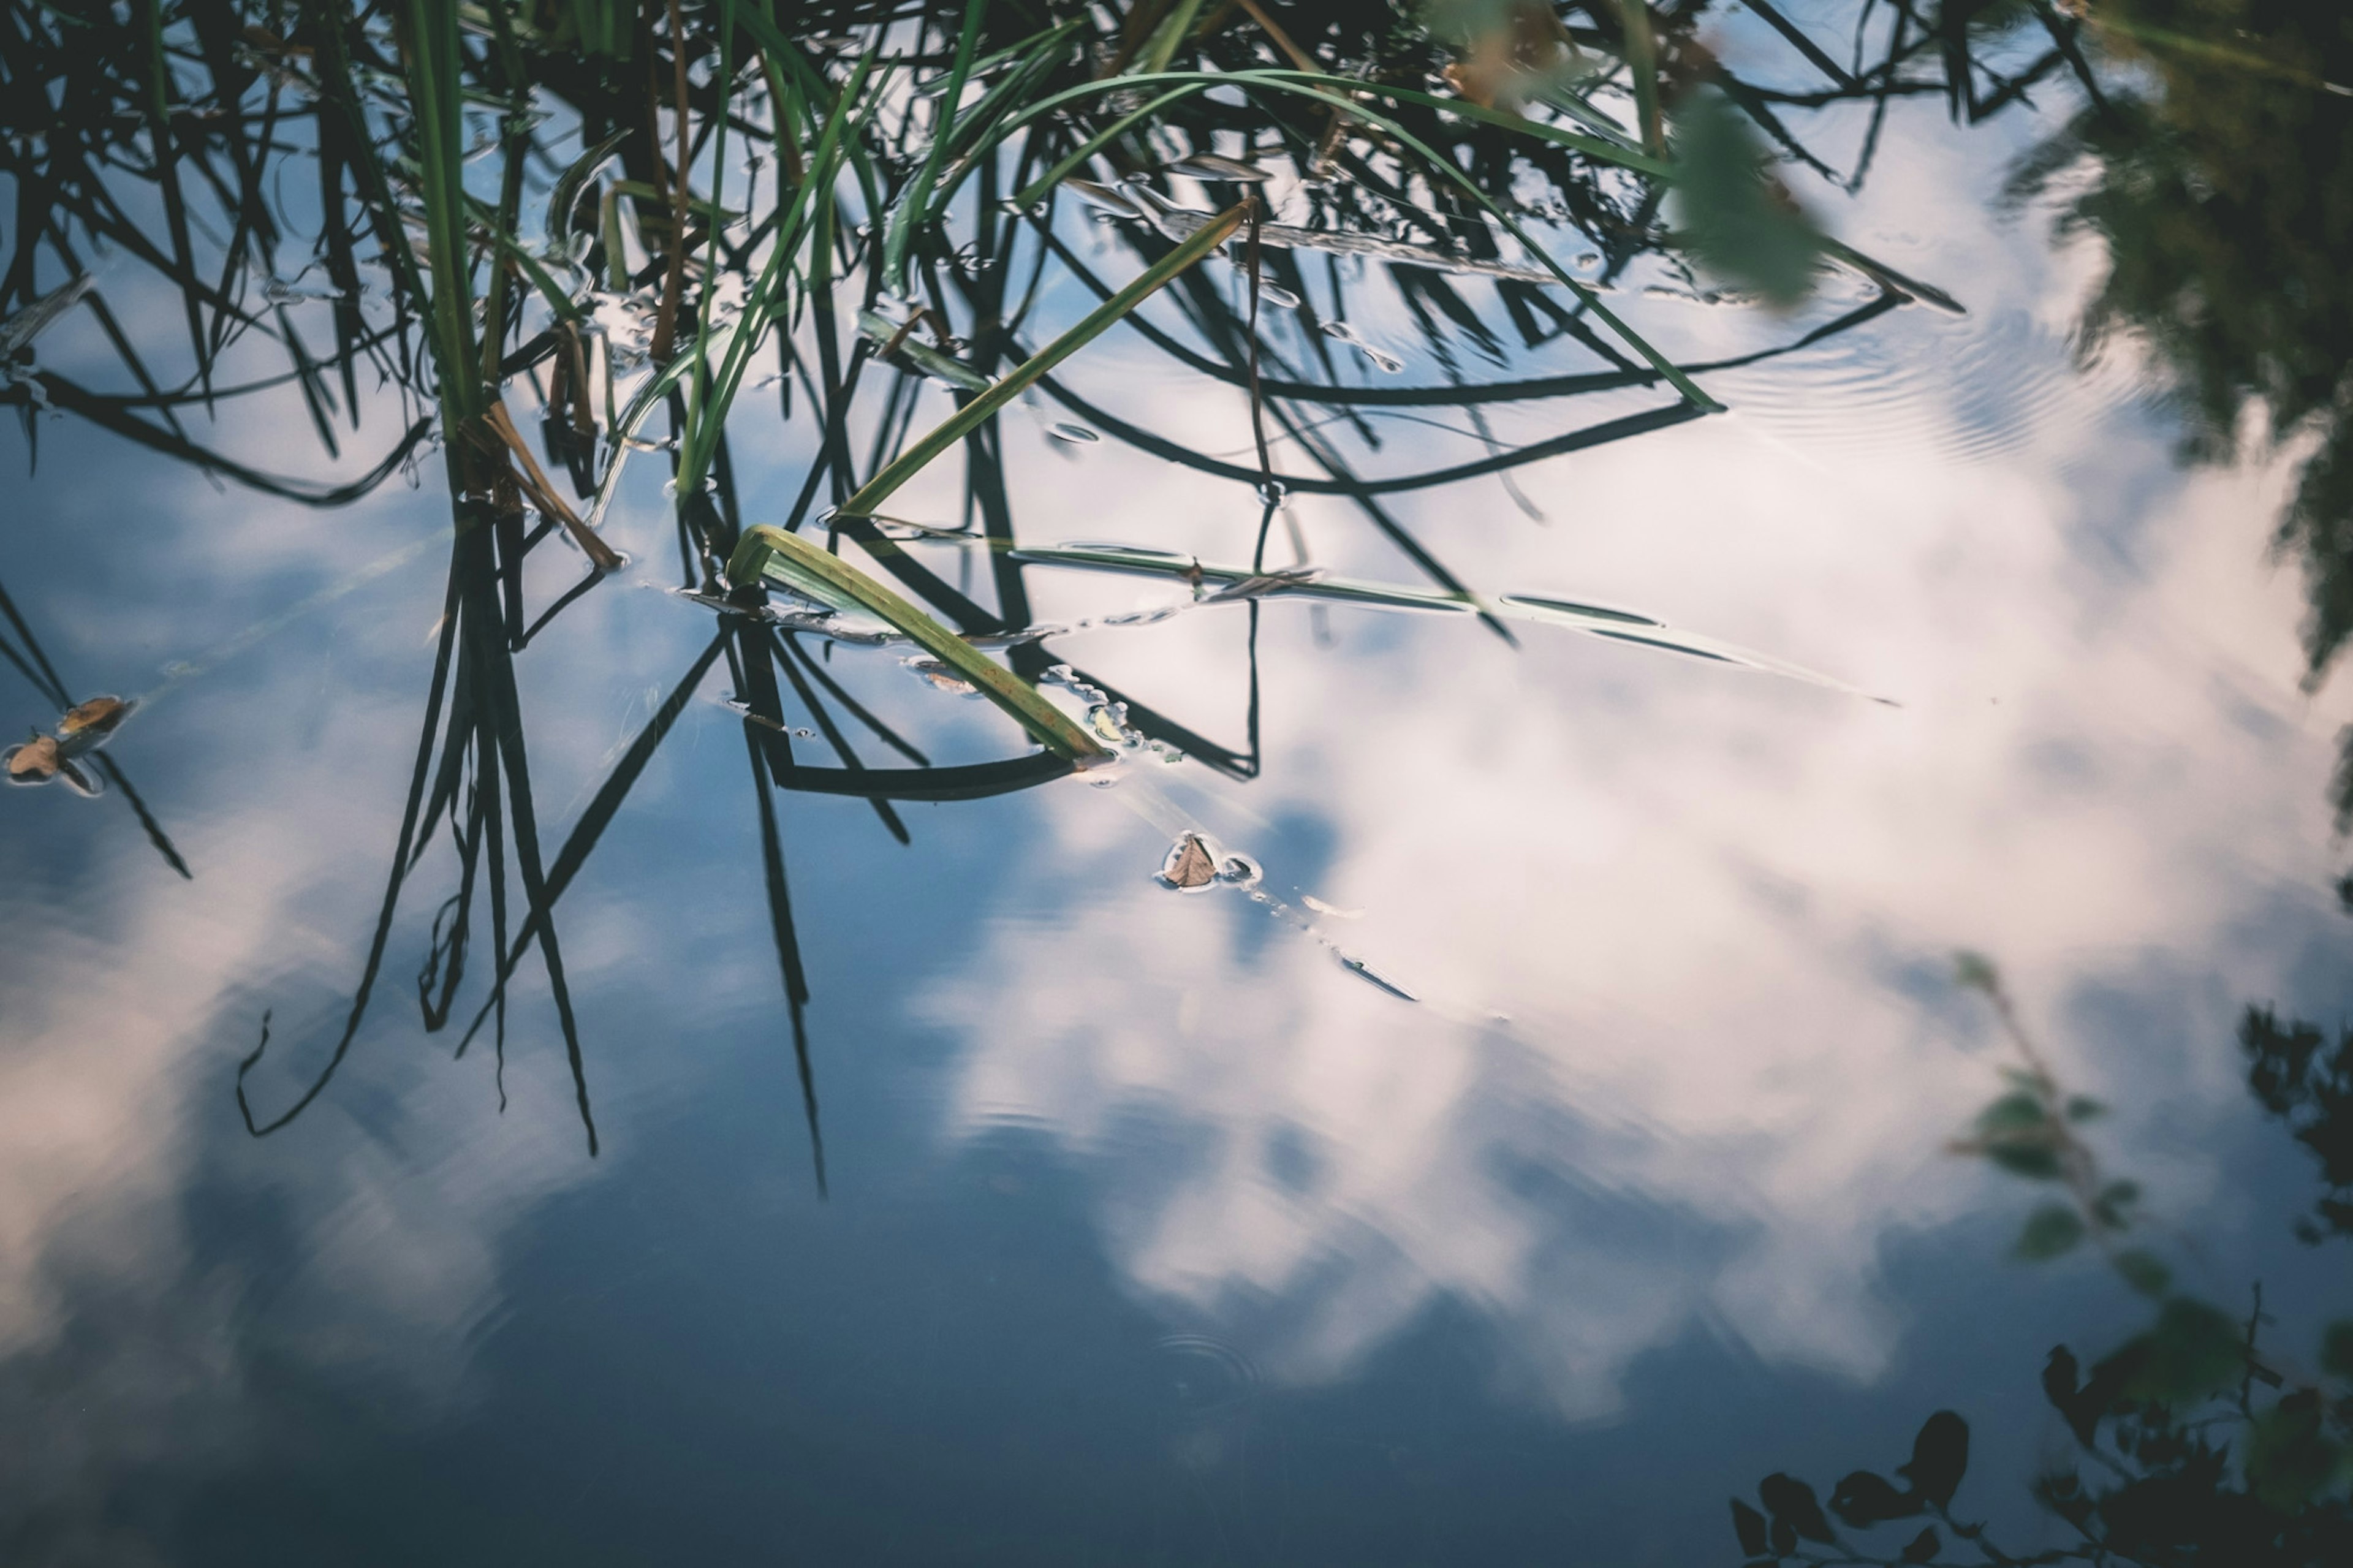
[0,0,2082,1158]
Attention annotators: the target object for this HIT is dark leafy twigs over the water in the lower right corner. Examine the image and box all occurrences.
[1732,956,2353,1568]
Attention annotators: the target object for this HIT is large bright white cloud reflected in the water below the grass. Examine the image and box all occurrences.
[922,148,2341,1417]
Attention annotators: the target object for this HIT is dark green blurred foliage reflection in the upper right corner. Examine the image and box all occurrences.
[2012,0,2353,824]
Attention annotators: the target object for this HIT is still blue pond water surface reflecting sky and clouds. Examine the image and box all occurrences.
[0,0,2353,1566]
